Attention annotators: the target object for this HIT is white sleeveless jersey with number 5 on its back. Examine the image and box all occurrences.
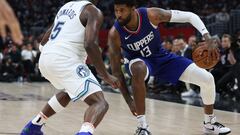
[42,1,91,63]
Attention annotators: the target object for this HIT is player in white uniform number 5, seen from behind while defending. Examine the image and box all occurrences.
[21,1,119,135]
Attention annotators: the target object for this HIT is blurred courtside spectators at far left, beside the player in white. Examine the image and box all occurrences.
[0,36,44,82]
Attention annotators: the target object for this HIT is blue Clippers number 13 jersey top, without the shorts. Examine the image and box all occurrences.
[114,8,171,59]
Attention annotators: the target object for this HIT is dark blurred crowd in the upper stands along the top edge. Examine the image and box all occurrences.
[6,0,240,32]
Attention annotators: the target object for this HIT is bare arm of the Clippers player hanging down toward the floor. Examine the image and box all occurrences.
[108,27,137,116]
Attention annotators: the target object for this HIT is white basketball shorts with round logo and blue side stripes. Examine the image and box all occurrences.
[39,54,102,101]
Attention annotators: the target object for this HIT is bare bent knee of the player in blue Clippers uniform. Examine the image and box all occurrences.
[131,61,147,79]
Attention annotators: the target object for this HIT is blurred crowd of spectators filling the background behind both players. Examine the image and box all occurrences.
[0,0,240,98]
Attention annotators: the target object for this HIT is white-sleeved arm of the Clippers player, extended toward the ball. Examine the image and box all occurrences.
[148,8,219,61]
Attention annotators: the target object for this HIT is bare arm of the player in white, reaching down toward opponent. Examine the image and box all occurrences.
[80,5,119,88]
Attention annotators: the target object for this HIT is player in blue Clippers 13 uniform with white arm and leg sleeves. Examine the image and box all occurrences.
[108,0,231,135]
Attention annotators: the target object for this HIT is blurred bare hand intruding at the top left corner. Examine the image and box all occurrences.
[0,0,23,45]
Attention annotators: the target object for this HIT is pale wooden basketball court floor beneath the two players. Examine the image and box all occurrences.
[0,83,240,135]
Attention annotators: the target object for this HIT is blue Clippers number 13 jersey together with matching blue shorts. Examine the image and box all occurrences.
[114,8,192,83]
